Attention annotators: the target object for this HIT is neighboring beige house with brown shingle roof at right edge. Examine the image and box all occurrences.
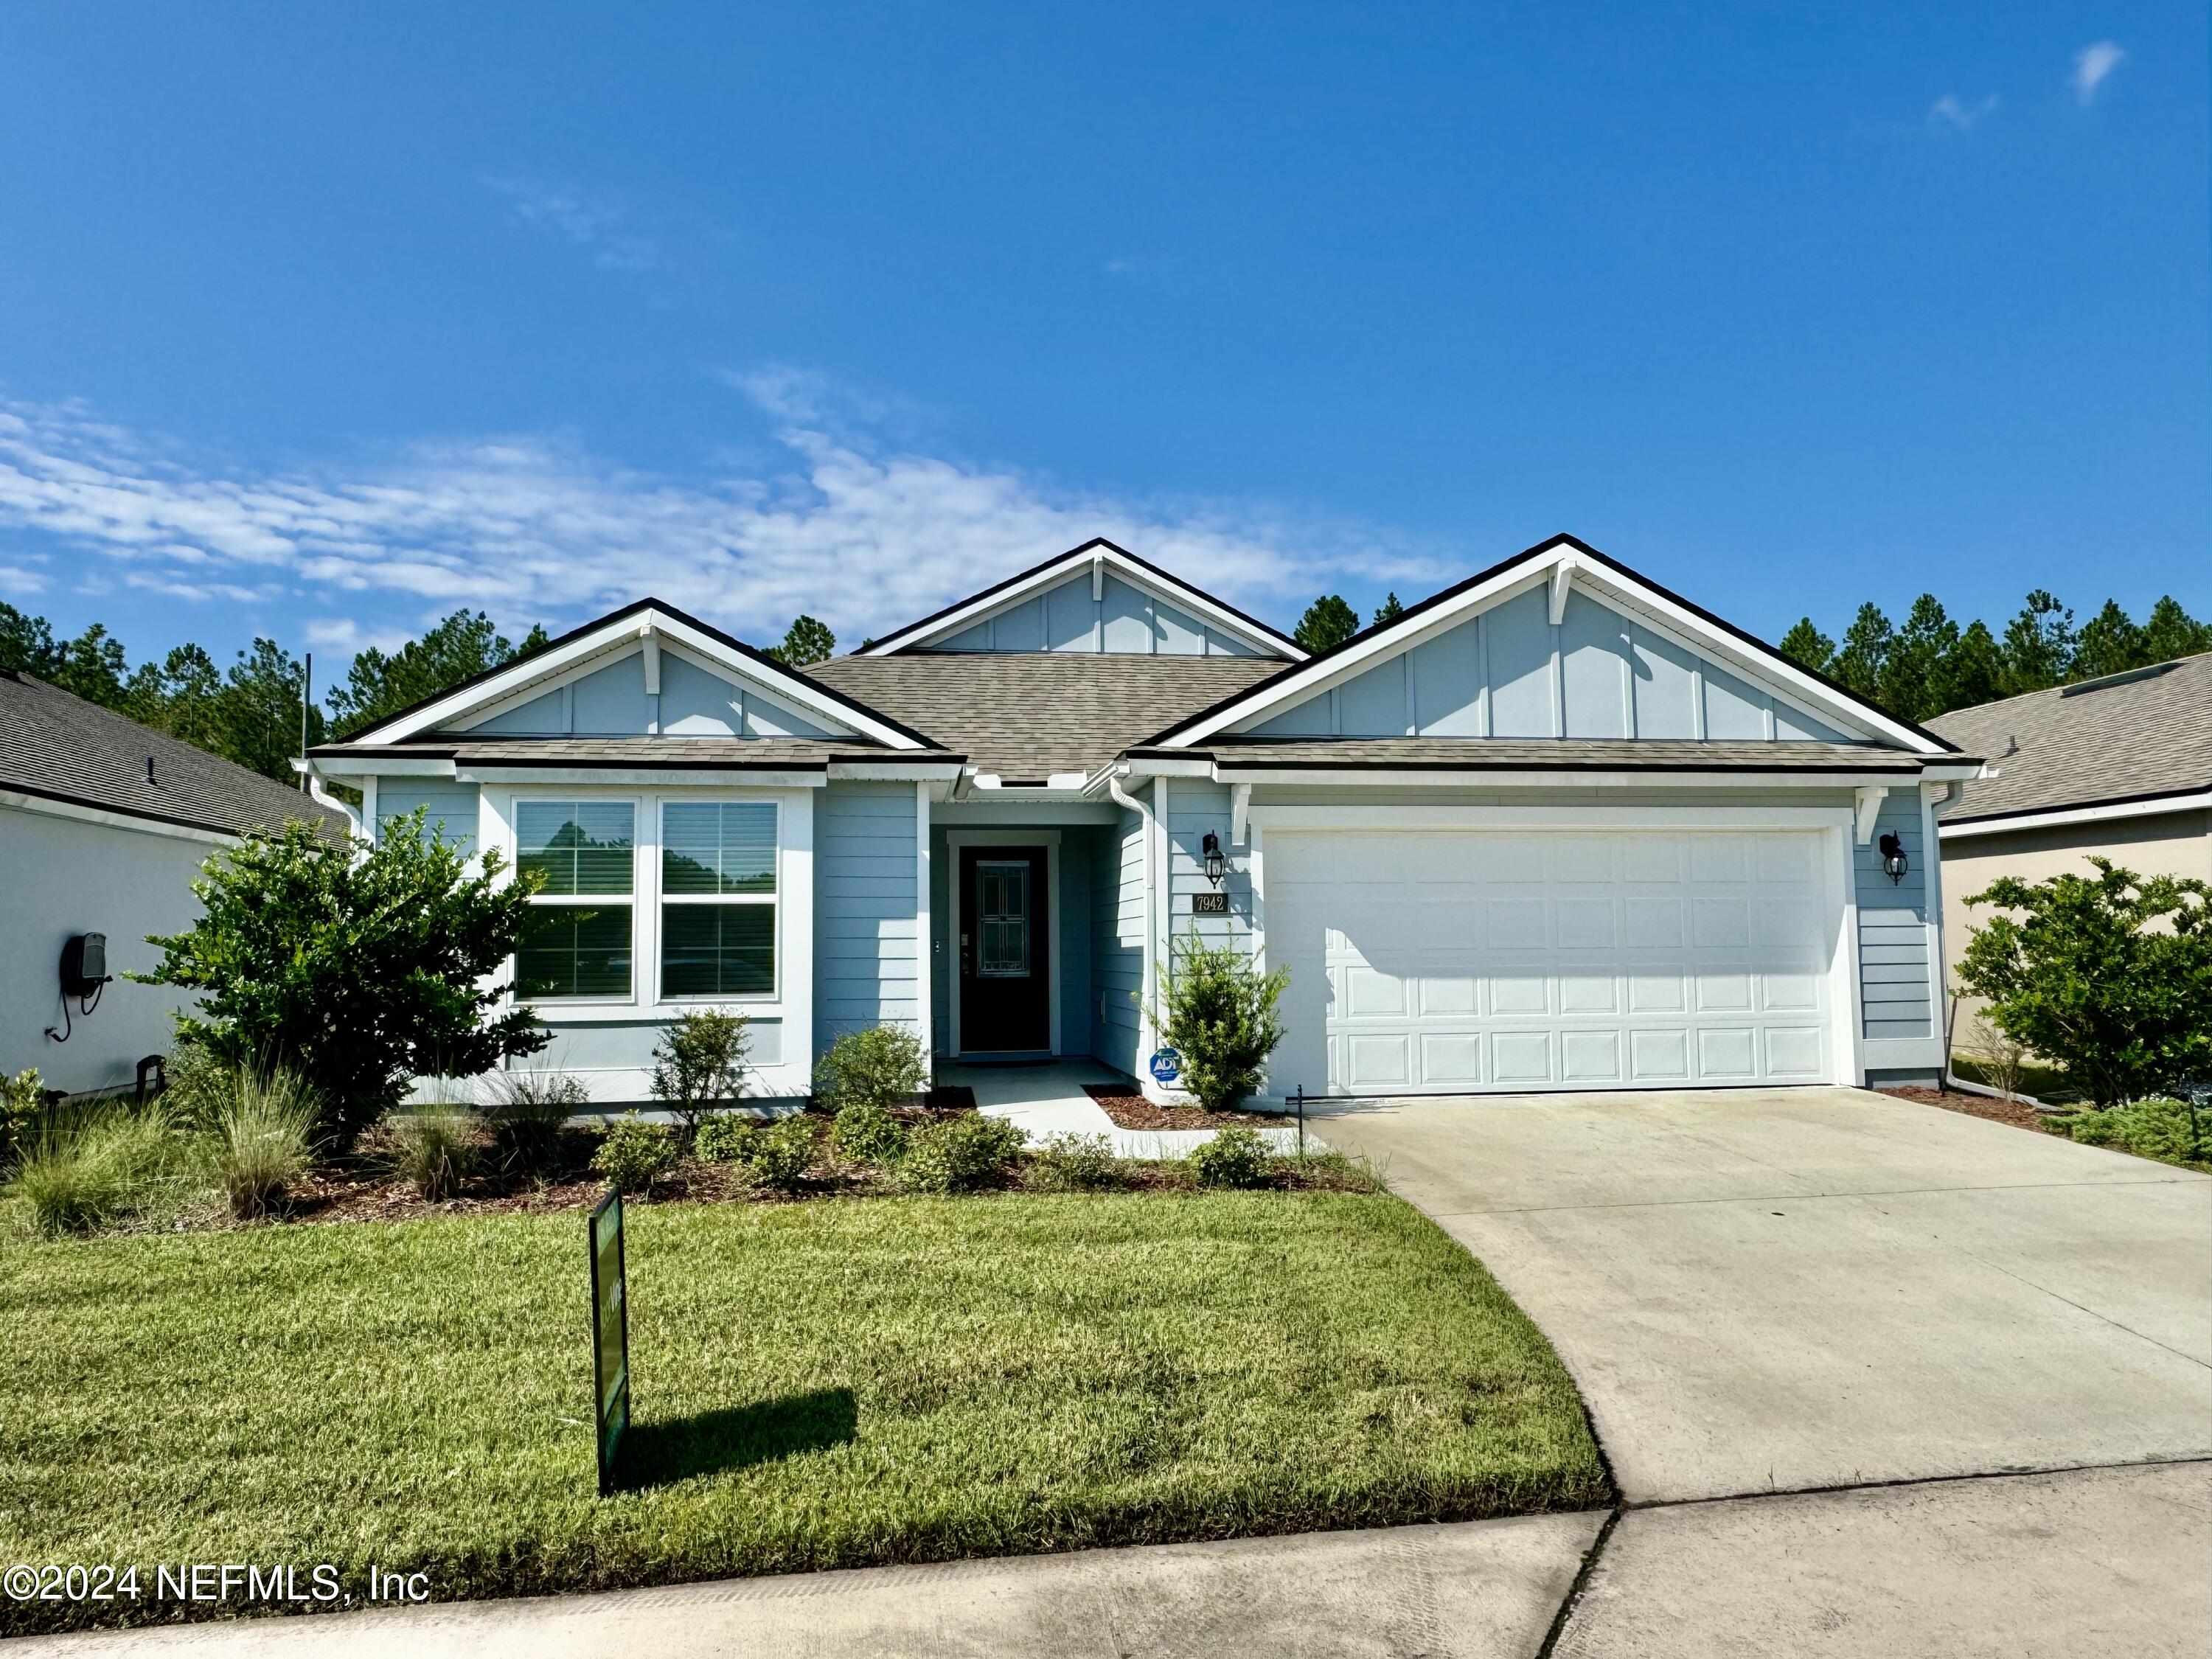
[1929,653,2212,1013]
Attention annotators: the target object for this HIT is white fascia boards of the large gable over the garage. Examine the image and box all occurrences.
[1166,542,1944,754]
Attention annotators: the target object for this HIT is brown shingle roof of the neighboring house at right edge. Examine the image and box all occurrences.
[1929,653,2212,823]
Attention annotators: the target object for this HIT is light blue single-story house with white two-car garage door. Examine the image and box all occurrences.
[310,535,1980,1099]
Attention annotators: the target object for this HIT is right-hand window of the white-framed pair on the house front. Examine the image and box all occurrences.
[661,801,776,1002]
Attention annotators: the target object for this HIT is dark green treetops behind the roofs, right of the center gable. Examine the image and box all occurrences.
[1292,588,2212,723]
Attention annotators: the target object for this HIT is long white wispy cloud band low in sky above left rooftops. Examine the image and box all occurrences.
[0,389,1451,646]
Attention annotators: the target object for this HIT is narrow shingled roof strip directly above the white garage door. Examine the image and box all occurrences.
[1139,737,1960,774]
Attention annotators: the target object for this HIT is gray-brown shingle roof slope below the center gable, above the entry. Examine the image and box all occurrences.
[807,653,1287,783]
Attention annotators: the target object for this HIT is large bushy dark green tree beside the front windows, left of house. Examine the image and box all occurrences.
[131,812,546,1148]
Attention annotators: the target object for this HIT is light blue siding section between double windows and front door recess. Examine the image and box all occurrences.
[814,783,922,1053]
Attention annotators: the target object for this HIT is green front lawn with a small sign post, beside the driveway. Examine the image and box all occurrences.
[0,1192,1610,1628]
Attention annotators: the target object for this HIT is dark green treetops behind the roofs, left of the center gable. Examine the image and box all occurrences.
[0,602,836,783]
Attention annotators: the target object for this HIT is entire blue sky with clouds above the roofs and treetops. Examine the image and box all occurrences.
[0,0,2212,672]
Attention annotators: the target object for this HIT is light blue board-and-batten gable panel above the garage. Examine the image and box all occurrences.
[1250,586,1851,743]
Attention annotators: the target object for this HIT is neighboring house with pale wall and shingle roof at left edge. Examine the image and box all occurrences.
[0,670,345,1093]
